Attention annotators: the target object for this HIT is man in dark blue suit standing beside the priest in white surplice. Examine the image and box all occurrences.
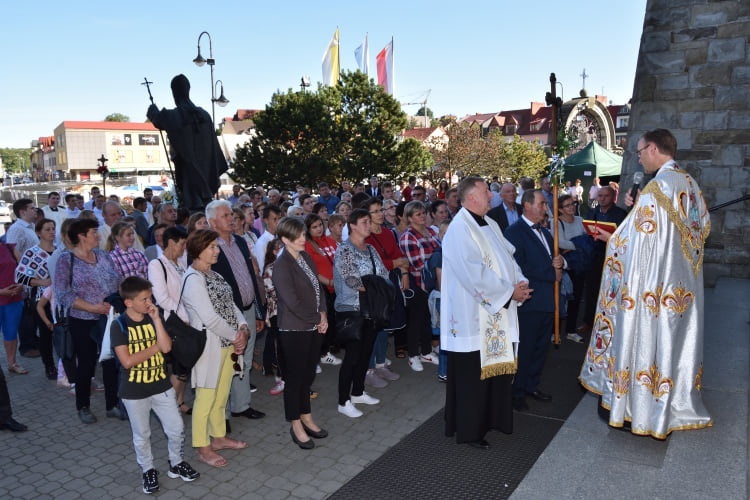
[504,189,565,411]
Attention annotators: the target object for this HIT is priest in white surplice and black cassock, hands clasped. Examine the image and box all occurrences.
[440,177,532,449]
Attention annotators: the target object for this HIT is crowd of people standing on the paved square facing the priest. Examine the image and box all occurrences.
[0,129,716,493]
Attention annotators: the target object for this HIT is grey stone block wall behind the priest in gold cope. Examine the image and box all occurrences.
[620,0,750,286]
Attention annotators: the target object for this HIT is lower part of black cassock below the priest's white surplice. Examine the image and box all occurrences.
[444,351,513,443]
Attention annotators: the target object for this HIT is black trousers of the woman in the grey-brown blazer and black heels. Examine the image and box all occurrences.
[279,331,323,422]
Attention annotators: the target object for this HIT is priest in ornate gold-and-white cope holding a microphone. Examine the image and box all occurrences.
[579,129,712,439]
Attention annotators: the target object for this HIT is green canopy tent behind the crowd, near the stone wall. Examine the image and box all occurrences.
[563,141,622,212]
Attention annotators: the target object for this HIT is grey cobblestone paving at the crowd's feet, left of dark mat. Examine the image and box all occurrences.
[0,353,445,499]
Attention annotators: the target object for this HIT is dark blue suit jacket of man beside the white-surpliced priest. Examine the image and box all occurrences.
[503,218,555,313]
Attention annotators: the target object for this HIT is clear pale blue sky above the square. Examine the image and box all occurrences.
[0,0,646,147]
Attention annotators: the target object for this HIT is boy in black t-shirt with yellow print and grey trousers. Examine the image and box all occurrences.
[110,276,200,493]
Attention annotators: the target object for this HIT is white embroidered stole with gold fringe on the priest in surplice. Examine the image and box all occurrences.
[456,210,518,380]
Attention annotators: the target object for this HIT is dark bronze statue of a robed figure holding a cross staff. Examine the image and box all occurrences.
[146,75,227,211]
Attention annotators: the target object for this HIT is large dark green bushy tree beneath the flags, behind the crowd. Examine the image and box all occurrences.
[234,71,412,188]
